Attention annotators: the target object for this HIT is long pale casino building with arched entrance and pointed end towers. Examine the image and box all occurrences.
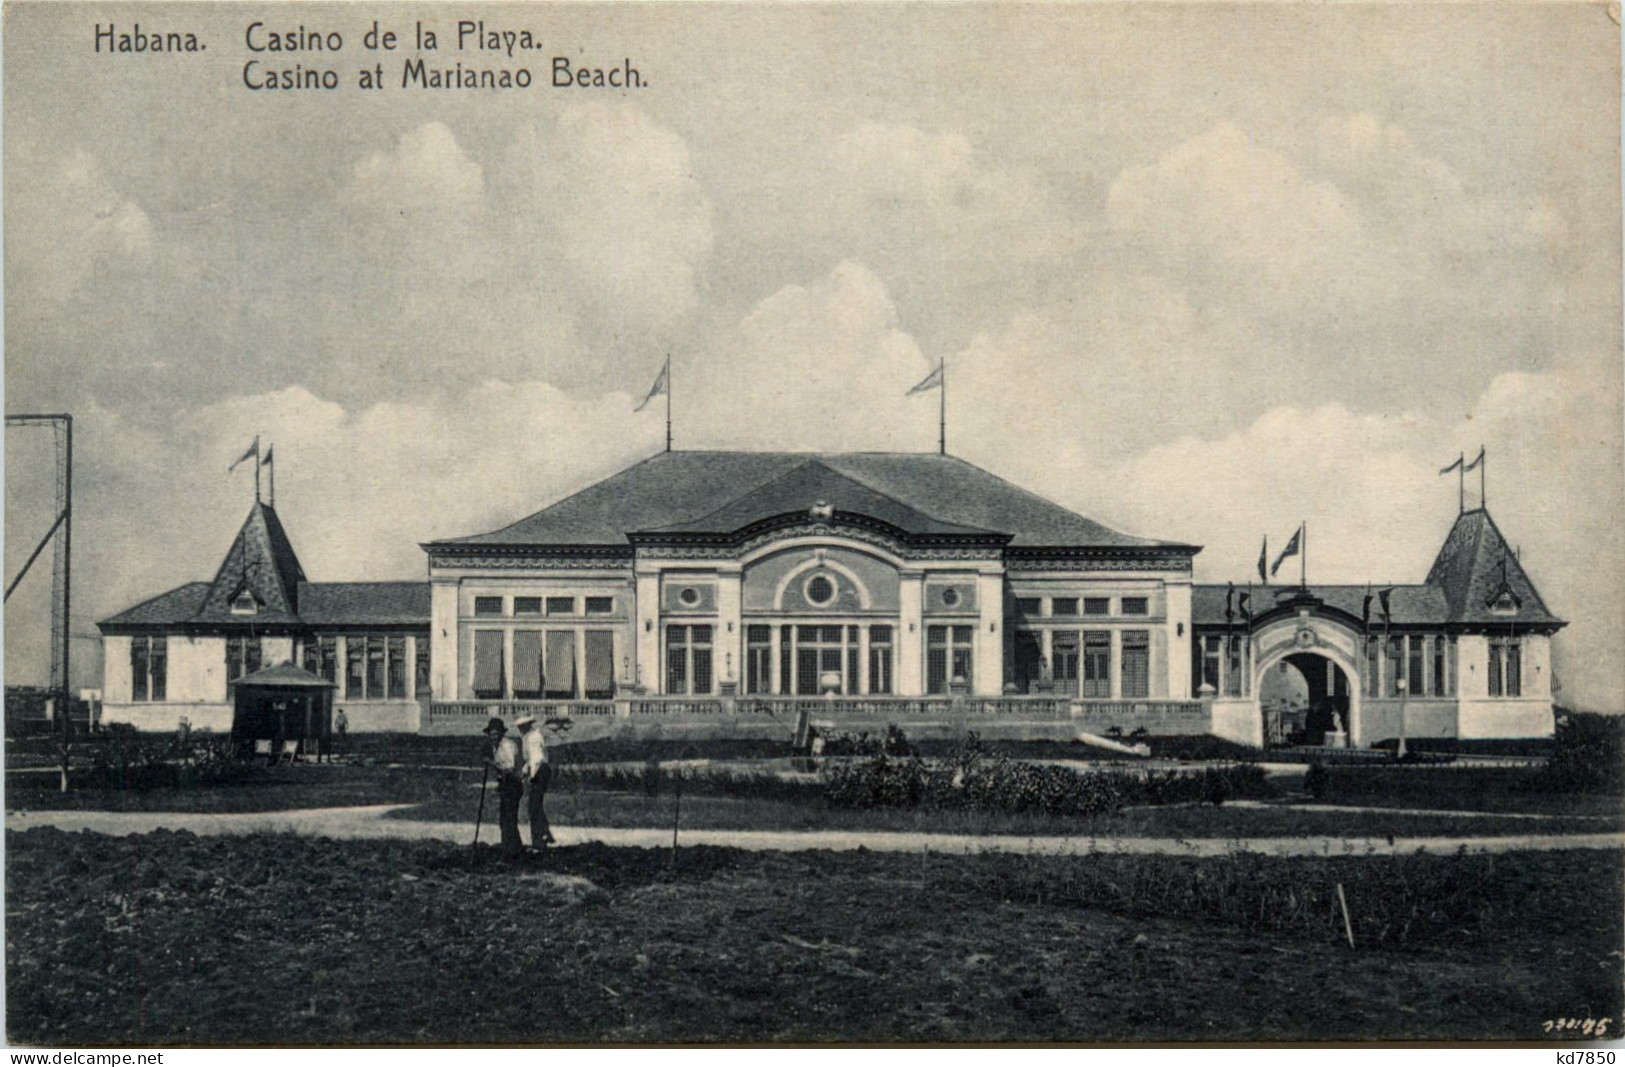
[99,451,1563,747]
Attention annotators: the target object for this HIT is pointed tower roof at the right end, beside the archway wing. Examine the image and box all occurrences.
[1427,508,1558,624]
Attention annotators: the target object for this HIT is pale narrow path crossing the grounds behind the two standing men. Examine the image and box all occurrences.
[5,804,1625,856]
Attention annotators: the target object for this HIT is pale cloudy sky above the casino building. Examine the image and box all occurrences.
[5,3,1625,710]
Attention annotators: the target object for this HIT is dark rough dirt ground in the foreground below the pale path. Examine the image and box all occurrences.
[7,830,1622,1046]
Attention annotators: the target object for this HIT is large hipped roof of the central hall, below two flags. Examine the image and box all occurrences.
[426,451,1196,552]
